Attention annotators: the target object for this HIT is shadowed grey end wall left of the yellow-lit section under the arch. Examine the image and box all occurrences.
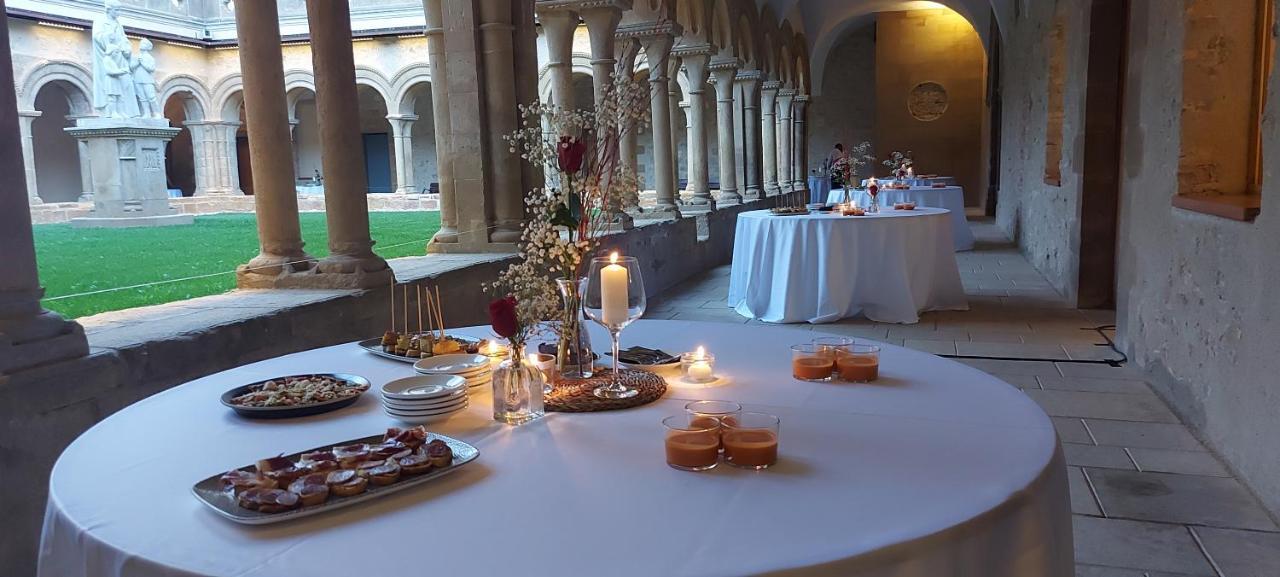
[808,20,876,175]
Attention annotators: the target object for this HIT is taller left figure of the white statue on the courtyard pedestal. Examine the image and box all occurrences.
[92,0,138,118]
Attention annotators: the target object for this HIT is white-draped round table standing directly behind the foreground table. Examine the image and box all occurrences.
[728,207,969,324]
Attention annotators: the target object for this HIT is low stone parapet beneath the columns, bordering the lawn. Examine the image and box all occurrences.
[0,197,798,576]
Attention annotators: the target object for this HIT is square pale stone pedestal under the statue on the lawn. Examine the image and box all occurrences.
[65,118,195,228]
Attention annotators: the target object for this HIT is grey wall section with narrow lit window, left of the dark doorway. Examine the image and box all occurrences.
[996,0,1088,302]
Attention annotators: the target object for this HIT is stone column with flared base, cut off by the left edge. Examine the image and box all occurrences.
[0,7,88,385]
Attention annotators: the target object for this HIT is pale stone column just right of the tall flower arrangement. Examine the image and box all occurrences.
[640,28,680,219]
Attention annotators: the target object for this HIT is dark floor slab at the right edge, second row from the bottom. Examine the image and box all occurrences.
[1085,468,1277,531]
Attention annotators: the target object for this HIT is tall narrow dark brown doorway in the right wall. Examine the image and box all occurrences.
[1076,0,1129,308]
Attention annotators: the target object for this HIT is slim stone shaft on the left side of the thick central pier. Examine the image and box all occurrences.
[422,0,458,245]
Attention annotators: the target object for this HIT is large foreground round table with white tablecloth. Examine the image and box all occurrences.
[40,321,1073,577]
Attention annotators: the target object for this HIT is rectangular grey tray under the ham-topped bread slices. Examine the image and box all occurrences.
[191,432,480,525]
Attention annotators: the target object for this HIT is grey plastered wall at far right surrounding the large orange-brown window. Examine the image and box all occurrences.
[1117,0,1280,513]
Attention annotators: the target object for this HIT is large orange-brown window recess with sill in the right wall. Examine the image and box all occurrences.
[1174,0,1275,220]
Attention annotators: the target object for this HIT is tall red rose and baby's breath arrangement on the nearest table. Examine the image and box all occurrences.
[488,74,649,371]
